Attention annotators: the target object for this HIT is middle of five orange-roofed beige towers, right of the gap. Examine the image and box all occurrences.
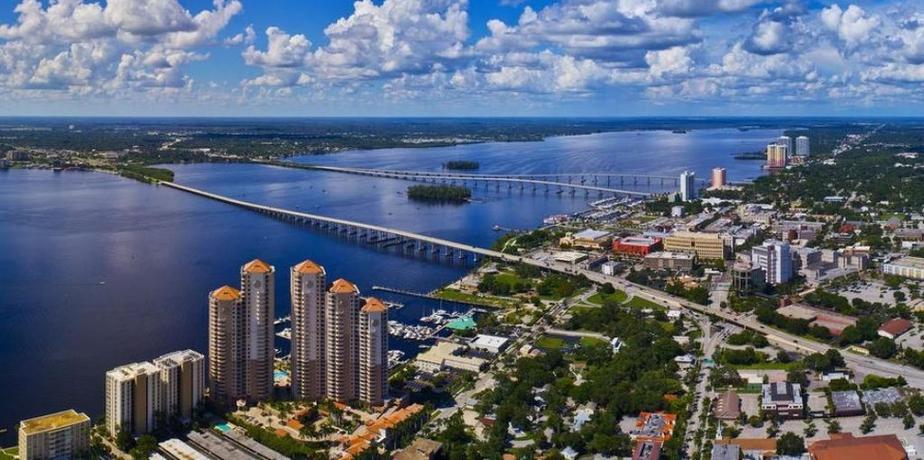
[289,260,327,400]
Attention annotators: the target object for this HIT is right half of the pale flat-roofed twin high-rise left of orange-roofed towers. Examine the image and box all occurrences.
[154,350,205,420]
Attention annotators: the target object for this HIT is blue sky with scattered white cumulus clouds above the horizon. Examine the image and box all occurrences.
[0,0,924,117]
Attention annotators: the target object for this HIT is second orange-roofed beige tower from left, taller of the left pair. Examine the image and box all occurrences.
[241,259,276,401]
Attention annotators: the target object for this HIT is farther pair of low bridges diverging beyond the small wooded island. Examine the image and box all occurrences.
[266,161,692,197]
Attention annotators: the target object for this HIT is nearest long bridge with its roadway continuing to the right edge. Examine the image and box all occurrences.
[161,182,924,388]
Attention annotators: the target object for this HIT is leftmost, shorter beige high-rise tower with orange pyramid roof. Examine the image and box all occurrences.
[208,286,246,406]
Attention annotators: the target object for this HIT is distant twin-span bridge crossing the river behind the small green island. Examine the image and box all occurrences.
[264,161,660,197]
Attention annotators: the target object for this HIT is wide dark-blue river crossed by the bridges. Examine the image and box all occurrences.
[0,129,780,445]
